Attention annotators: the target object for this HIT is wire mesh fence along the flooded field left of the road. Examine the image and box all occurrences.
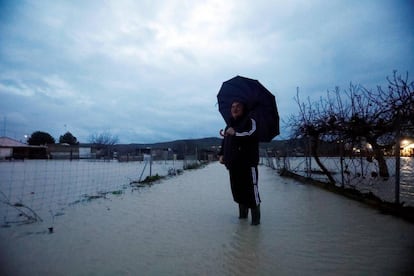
[0,160,191,227]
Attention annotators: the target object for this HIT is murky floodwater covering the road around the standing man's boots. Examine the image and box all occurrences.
[0,163,414,275]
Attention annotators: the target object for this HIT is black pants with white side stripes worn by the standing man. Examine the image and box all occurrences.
[229,166,260,208]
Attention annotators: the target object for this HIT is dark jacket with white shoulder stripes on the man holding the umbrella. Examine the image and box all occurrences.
[219,116,259,169]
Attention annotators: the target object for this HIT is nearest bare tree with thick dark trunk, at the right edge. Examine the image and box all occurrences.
[344,71,414,177]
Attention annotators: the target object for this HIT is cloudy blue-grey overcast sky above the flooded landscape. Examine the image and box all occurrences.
[0,0,414,143]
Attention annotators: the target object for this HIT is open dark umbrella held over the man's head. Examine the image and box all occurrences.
[217,76,279,142]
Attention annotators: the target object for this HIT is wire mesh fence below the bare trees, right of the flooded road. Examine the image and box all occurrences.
[263,147,414,206]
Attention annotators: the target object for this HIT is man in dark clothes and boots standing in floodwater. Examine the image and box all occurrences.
[219,101,261,225]
